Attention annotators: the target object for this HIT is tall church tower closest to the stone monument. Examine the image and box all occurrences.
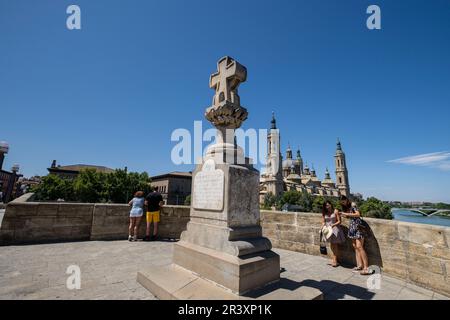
[265,112,284,195]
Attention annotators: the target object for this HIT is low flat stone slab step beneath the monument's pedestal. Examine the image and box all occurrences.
[137,264,323,300]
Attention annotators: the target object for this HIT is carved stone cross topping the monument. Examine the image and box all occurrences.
[209,56,247,106]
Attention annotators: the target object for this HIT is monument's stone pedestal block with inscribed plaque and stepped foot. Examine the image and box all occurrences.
[173,158,280,295]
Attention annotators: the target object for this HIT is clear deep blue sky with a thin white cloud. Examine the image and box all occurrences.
[0,0,450,202]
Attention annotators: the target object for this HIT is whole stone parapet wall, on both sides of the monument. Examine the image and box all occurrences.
[0,194,450,296]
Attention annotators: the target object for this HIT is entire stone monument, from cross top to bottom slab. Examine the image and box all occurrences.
[138,57,320,299]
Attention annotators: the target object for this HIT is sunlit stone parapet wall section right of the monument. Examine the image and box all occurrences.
[261,211,450,296]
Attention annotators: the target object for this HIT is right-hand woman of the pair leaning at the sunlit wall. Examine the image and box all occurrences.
[341,196,372,276]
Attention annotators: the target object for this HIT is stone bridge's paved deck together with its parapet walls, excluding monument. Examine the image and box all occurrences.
[0,194,450,299]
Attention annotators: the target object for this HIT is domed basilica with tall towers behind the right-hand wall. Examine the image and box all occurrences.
[260,114,350,203]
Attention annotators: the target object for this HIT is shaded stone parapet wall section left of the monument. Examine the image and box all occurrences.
[0,194,189,245]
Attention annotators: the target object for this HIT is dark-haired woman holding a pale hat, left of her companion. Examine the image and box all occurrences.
[321,201,345,268]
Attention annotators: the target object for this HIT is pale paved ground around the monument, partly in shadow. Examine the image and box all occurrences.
[0,241,448,300]
